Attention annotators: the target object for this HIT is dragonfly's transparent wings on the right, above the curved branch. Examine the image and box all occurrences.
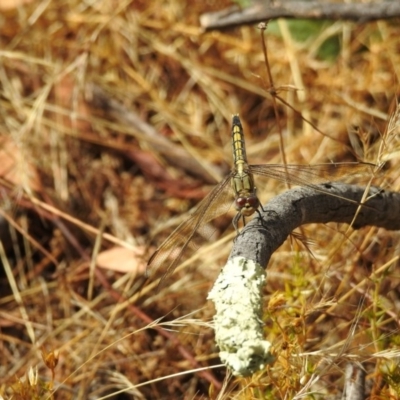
[249,163,375,194]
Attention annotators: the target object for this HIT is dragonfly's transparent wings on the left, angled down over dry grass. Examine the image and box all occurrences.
[147,175,233,283]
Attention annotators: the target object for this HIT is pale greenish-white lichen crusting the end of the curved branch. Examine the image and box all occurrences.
[208,257,274,376]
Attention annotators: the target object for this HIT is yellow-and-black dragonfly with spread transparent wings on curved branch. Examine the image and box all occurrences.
[147,114,374,283]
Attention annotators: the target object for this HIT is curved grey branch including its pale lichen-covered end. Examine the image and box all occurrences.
[208,183,400,376]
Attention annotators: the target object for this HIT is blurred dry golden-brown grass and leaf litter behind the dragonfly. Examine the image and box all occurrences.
[0,0,400,399]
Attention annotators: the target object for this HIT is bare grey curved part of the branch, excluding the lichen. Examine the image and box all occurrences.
[229,183,400,266]
